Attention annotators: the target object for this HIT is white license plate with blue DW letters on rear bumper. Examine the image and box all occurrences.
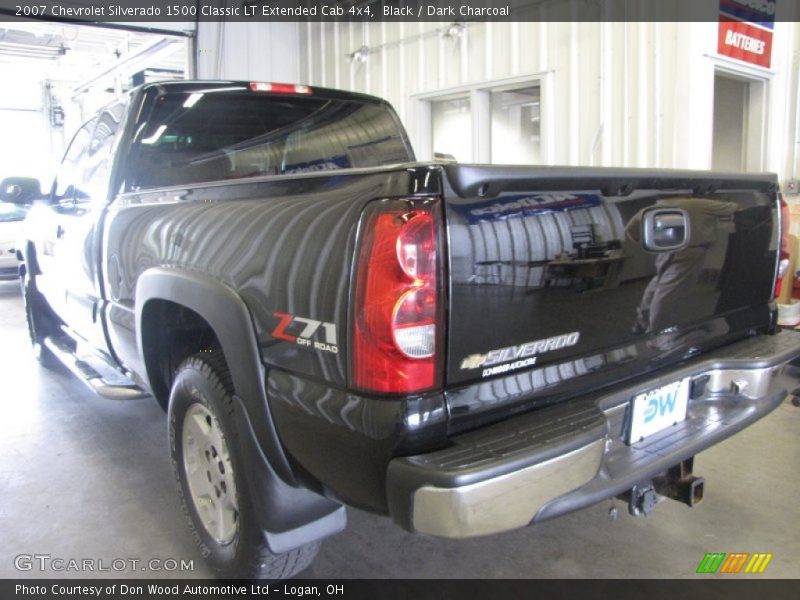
[628,377,690,444]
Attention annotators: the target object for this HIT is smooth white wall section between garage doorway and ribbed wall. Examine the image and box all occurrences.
[195,22,300,82]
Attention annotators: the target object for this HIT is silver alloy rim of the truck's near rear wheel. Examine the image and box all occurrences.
[181,402,239,544]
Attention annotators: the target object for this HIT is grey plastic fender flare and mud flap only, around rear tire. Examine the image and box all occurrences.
[136,267,346,553]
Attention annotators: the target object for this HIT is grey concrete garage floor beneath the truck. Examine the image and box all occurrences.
[0,282,800,579]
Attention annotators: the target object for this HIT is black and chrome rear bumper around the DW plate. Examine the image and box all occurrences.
[387,332,800,538]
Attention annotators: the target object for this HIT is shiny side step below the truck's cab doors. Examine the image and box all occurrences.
[44,335,150,400]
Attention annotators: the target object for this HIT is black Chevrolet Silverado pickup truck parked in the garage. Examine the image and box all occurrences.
[3,81,800,578]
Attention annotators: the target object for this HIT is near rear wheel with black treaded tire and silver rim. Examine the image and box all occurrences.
[168,351,320,580]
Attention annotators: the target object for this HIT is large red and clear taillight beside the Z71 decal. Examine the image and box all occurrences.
[352,200,444,394]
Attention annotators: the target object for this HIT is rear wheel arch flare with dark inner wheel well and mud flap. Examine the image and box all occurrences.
[136,267,346,552]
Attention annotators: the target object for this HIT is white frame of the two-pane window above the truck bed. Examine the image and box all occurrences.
[410,71,555,164]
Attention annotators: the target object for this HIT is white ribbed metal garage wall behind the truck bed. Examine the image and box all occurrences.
[299,22,800,185]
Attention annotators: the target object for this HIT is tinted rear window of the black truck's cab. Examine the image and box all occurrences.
[125,85,413,191]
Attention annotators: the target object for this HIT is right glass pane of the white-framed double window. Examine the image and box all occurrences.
[492,86,541,165]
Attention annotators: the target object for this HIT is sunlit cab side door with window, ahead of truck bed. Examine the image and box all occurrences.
[37,103,124,350]
